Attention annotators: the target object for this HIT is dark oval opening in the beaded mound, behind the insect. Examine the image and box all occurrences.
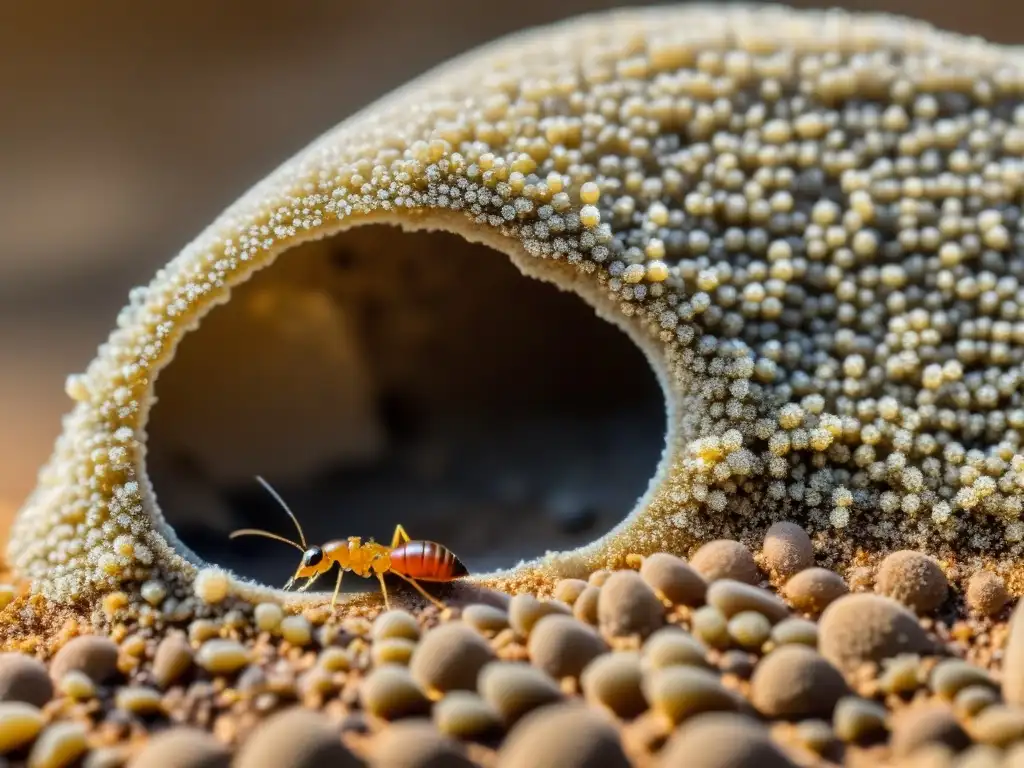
[146,224,666,591]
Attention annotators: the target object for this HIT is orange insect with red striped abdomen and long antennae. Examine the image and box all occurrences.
[228,476,469,609]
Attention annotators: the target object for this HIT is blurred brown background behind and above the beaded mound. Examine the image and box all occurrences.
[0,0,1024,561]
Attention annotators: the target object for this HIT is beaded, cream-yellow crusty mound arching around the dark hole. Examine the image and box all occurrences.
[9,6,1024,601]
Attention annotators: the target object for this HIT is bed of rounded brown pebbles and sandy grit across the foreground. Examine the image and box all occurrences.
[0,523,1024,768]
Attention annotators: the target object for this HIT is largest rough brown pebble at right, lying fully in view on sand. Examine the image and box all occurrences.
[818,593,932,672]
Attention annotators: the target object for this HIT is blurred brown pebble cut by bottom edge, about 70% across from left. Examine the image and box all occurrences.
[656,713,796,768]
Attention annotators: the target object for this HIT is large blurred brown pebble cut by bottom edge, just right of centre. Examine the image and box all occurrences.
[496,702,630,768]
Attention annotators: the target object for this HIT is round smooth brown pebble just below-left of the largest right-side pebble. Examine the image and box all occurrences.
[751,645,848,719]
